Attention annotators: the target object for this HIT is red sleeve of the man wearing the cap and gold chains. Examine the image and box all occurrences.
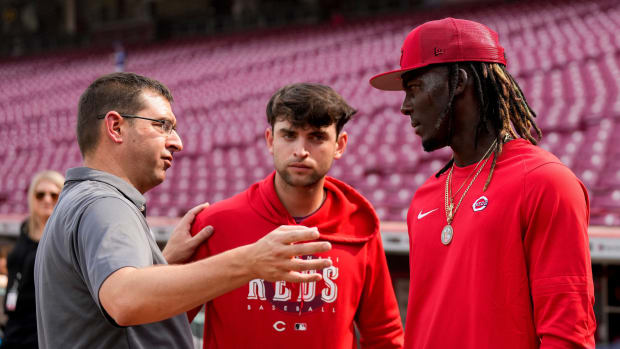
[522,163,596,349]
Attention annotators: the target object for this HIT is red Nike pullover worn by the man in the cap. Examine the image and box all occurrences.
[405,139,596,349]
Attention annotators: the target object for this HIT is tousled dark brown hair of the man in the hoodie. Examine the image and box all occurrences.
[267,82,357,135]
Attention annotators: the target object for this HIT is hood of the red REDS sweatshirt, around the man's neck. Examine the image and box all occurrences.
[246,171,379,244]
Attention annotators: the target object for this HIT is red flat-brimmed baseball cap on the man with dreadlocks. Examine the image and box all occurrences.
[370,18,506,91]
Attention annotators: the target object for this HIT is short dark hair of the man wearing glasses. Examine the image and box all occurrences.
[77,73,173,157]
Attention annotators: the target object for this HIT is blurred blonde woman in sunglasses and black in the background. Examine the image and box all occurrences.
[0,171,65,349]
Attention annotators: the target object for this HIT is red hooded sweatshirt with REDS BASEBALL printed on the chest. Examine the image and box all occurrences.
[188,172,403,349]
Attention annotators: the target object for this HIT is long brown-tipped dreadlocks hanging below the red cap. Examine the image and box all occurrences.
[438,62,542,191]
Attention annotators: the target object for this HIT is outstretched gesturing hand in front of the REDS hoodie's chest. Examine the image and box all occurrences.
[245,225,332,282]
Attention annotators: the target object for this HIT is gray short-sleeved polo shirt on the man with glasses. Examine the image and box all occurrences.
[35,167,193,349]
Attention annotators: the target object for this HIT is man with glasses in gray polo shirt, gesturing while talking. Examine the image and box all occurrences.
[35,73,331,348]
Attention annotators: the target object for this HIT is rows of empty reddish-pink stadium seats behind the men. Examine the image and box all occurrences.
[0,0,620,225]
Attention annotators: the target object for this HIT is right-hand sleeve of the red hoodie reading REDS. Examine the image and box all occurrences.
[356,234,404,349]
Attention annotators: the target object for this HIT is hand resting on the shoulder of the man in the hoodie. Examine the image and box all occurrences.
[163,203,213,264]
